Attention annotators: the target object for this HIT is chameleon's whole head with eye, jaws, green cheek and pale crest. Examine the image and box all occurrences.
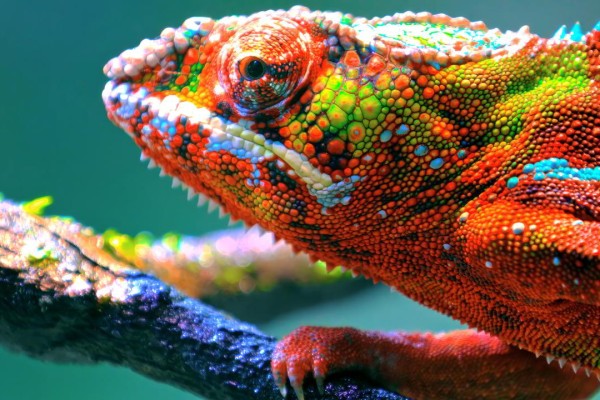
[103,7,544,263]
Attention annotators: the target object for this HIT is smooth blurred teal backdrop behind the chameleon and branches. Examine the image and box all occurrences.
[0,0,600,400]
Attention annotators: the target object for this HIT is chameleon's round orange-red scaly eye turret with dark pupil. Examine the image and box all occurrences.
[215,17,325,116]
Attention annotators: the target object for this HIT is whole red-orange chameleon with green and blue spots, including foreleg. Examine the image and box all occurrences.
[103,7,600,399]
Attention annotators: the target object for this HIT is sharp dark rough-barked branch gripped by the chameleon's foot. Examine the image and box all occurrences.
[0,202,404,400]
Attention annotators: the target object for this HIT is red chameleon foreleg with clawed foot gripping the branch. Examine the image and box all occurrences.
[271,326,599,400]
